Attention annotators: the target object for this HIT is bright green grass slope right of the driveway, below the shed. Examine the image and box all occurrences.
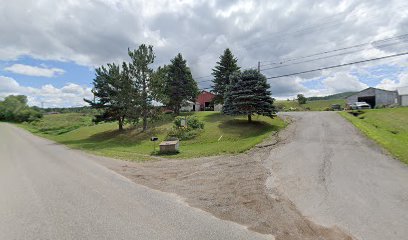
[340,107,408,164]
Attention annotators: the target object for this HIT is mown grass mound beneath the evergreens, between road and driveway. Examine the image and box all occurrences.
[21,112,285,160]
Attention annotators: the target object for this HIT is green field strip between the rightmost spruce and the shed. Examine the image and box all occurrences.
[275,99,346,111]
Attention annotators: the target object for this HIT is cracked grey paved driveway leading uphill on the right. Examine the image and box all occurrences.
[266,112,408,240]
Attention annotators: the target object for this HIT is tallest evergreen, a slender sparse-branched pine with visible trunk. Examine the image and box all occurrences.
[128,44,155,131]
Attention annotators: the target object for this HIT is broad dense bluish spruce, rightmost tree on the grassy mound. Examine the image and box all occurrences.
[223,70,275,122]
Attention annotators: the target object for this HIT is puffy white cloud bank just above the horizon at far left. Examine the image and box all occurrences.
[0,76,93,107]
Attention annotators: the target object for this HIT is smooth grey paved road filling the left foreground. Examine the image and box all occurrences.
[0,124,273,240]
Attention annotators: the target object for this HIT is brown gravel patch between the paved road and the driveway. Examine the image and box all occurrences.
[95,115,352,240]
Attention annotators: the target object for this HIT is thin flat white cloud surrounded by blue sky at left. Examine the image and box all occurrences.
[4,64,65,77]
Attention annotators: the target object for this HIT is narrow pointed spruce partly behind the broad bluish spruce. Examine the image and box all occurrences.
[212,48,240,104]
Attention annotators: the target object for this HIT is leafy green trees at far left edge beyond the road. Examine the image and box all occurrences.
[0,95,43,123]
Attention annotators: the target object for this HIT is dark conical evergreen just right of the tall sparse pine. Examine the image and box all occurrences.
[164,53,198,115]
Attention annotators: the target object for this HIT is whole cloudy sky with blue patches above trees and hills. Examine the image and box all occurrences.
[0,0,408,107]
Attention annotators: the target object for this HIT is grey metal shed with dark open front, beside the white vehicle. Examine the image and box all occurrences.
[347,87,398,108]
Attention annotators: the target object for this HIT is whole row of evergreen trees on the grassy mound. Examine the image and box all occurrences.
[84,44,275,130]
